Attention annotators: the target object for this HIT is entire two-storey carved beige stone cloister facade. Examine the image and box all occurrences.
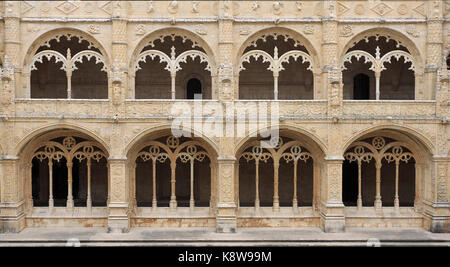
[0,0,450,232]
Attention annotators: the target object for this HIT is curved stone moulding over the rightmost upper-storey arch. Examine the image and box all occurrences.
[340,27,424,70]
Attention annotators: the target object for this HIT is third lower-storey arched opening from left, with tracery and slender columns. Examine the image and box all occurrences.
[235,130,323,222]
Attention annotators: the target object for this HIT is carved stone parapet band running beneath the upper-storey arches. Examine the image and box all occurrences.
[5,99,442,119]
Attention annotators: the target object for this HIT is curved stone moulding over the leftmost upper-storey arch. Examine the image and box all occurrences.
[23,27,111,68]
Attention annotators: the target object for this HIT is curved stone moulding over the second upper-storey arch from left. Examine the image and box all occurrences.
[128,27,217,73]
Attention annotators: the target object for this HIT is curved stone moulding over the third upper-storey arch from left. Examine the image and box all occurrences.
[235,27,321,73]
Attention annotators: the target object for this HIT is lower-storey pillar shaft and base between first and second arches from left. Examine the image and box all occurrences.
[108,157,130,233]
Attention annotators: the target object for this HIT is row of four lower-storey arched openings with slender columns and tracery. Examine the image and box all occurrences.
[10,125,431,230]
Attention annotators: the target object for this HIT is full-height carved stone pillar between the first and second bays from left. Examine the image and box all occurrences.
[108,1,131,233]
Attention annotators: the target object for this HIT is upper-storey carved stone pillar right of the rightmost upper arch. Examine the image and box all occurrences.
[426,1,443,99]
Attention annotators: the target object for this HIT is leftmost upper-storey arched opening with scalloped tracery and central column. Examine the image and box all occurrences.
[24,30,110,99]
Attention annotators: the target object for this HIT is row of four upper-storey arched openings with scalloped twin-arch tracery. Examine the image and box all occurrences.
[19,29,423,100]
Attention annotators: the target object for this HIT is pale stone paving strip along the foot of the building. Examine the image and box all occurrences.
[0,228,450,247]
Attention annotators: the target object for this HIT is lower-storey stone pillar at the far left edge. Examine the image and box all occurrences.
[0,156,25,233]
